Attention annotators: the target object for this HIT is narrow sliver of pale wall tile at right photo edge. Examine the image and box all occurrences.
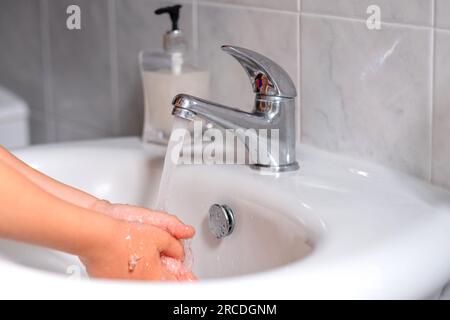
[432,32,450,189]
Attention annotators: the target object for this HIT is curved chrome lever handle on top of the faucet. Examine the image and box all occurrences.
[222,46,297,98]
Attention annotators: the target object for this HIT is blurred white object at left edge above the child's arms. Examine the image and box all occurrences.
[0,86,30,148]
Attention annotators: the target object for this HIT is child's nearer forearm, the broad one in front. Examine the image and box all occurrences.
[0,161,115,256]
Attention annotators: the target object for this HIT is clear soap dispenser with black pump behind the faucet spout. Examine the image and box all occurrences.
[139,5,209,144]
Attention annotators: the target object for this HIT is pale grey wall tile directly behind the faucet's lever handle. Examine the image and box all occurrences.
[198,4,299,110]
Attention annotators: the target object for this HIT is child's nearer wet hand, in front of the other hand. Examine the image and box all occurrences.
[80,220,193,281]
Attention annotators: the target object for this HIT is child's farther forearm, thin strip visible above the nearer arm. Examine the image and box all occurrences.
[0,147,99,209]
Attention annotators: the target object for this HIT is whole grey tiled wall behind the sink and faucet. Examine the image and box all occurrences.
[0,0,450,188]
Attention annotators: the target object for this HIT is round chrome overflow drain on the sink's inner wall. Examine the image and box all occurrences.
[209,204,236,239]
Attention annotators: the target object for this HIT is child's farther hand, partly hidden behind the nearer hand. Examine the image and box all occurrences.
[92,200,195,239]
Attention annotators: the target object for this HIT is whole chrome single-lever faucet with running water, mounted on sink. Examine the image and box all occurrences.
[172,46,299,172]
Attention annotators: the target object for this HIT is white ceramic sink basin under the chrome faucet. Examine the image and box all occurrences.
[0,138,450,299]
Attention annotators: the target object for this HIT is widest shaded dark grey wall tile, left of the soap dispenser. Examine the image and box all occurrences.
[48,0,115,133]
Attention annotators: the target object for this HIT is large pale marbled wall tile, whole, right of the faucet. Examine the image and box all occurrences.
[301,17,431,178]
